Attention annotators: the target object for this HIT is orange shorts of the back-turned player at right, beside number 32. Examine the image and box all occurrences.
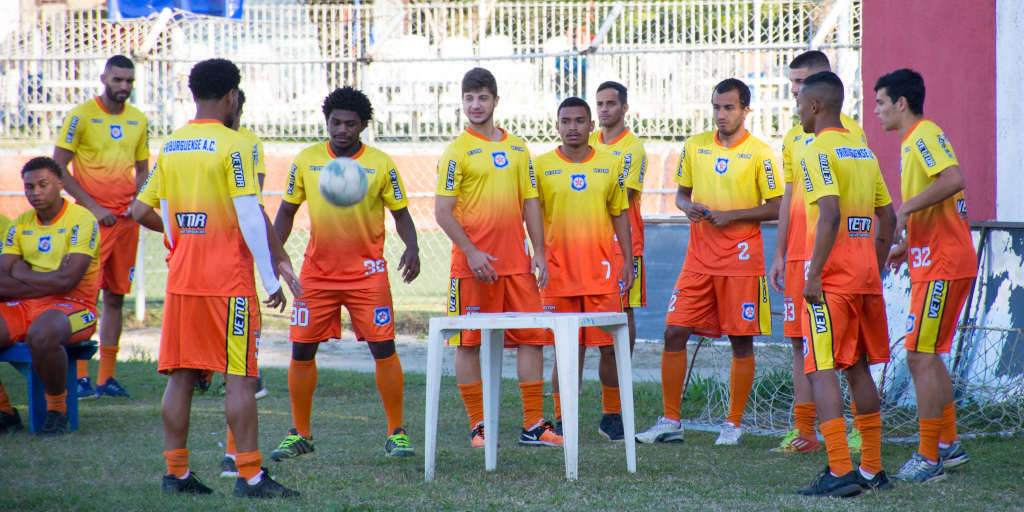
[804,292,889,374]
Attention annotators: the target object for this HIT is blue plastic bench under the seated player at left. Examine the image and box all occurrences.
[0,340,97,433]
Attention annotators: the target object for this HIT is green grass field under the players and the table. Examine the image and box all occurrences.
[0,361,1024,511]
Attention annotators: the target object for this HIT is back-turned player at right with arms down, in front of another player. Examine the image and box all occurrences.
[797,72,895,497]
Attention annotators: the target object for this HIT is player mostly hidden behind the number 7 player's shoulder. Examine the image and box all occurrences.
[590,82,647,352]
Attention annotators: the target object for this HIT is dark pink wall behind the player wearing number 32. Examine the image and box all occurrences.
[861,0,996,220]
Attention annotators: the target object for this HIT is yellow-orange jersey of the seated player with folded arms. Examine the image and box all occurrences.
[3,200,99,305]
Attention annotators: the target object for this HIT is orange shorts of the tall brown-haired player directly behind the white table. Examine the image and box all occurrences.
[449,273,554,348]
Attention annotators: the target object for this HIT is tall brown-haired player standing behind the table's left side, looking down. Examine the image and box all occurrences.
[434,68,562,447]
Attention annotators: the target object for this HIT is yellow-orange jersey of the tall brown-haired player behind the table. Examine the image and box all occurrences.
[434,128,537,278]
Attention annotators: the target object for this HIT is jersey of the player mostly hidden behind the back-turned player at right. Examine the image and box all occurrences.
[782,114,867,261]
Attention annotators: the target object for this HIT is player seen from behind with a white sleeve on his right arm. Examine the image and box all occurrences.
[133,58,302,498]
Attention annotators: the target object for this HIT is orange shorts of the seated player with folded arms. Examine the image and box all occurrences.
[0,297,96,343]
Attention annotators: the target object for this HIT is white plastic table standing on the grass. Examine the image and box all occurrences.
[424,312,637,481]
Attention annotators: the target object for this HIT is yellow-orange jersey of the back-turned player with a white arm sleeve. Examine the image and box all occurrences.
[153,120,259,297]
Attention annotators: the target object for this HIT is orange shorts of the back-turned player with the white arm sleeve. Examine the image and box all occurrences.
[158,293,260,377]
